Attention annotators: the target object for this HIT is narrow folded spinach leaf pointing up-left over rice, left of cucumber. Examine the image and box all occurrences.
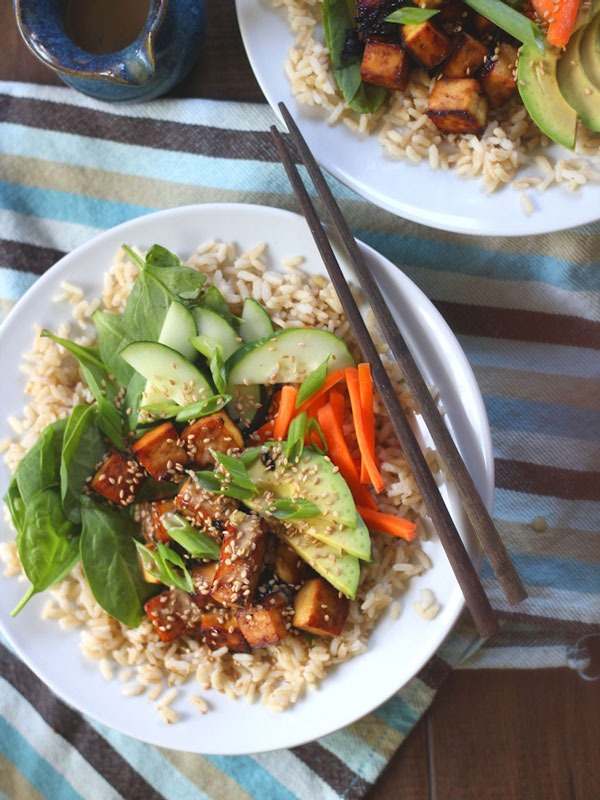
[42,330,125,450]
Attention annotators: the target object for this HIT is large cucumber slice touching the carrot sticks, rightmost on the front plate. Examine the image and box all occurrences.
[226,328,354,385]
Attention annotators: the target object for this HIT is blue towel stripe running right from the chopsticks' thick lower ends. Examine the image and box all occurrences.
[481,542,600,602]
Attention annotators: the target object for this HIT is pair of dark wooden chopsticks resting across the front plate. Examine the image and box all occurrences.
[271,103,527,637]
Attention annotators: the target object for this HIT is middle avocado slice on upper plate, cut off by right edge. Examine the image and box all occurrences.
[556,27,600,131]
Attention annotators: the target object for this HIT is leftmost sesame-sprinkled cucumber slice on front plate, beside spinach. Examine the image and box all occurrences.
[121,342,215,406]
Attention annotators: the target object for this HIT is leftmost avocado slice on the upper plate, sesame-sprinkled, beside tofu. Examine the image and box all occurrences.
[517,44,577,150]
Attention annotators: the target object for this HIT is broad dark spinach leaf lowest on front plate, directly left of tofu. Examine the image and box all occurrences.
[80,500,153,628]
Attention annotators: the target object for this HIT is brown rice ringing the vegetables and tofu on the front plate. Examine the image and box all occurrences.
[0,242,438,723]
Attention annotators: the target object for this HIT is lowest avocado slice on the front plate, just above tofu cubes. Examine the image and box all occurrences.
[277,531,360,600]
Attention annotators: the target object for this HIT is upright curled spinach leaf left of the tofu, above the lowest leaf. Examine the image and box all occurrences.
[60,403,106,525]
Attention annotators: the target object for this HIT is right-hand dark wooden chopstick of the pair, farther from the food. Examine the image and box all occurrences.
[279,103,527,605]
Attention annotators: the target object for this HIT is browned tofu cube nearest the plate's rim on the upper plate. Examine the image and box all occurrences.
[427,78,488,134]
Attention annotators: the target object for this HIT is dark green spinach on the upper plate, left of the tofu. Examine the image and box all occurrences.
[323,0,388,114]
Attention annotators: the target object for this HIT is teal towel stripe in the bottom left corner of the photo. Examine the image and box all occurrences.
[0,717,83,800]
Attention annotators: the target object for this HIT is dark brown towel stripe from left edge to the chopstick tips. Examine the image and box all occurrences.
[0,95,279,162]
